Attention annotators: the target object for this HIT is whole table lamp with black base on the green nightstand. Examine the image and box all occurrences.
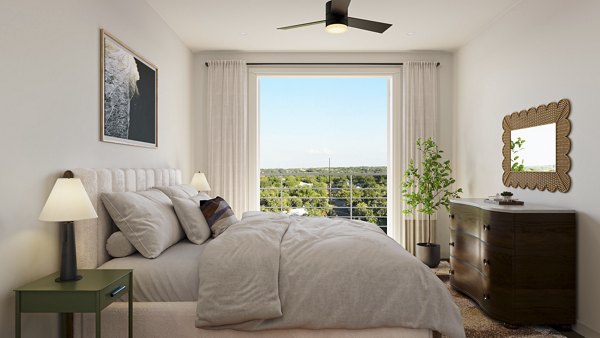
[39,171,98,282]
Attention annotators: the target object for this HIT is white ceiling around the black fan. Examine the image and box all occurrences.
[146,0,521,52]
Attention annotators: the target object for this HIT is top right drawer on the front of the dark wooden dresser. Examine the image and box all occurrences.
[481,210,515,248]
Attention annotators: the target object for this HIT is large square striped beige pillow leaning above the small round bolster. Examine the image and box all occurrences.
[101,189,185,258]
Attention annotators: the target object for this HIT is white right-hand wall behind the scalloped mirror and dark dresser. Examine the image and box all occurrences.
[454,0,600,337]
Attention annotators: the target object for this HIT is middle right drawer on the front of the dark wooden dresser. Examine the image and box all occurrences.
[480,242,514,287]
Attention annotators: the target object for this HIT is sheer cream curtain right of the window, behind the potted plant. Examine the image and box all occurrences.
[397,62,438,254]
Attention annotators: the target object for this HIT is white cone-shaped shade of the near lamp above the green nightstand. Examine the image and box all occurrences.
[39,178,98,222]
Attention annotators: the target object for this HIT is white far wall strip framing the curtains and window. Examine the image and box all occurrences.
[194,52,454,257]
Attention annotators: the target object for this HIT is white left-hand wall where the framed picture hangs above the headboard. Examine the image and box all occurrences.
[0,0,193,337]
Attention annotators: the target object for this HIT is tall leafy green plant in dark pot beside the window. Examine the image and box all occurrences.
[402,138,462,268]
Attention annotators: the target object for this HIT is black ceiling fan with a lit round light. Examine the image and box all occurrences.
[277,0,392,34]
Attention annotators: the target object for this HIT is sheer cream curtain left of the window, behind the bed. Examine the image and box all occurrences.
[206,61,250,218]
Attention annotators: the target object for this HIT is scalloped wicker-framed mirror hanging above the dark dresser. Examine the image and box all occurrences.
[502,99,571,192]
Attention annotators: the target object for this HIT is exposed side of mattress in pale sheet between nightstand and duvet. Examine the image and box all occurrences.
[99,240,210,302]
